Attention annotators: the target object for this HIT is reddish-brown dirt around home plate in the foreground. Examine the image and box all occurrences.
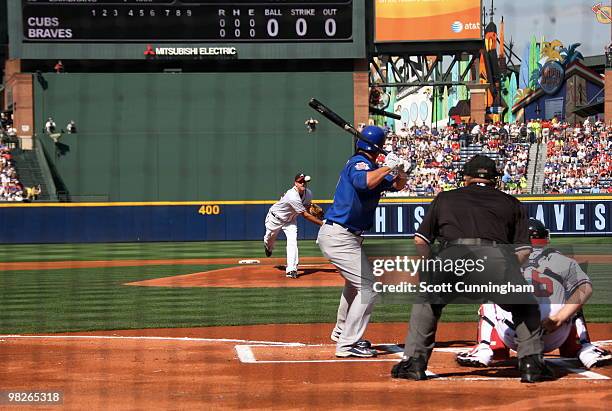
[0,323,612,410]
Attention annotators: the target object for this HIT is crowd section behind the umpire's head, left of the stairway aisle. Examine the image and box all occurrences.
[385,120,529,196]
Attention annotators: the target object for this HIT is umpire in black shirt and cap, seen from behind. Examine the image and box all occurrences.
[391,156,547,382]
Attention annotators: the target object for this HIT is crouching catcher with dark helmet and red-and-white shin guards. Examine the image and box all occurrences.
[456,218,612,368]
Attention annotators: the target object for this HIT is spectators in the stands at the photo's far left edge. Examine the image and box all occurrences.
[0,112,25,201]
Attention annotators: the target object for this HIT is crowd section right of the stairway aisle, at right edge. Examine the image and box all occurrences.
[544,119,612,194]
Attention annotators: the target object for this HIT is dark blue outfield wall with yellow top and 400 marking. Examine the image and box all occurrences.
[0,195,612,243]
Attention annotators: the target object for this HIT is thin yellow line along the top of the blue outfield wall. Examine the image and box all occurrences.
[0,194,612,208]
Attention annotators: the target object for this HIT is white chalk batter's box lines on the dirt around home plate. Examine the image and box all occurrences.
[234,340,612,381]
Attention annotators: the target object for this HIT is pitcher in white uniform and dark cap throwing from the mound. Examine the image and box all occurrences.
[264,173,323,278]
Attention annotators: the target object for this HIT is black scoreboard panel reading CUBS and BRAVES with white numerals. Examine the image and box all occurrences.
[22,0,353,43]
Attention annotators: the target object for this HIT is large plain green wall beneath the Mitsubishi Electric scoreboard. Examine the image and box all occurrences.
[34,72,353,201]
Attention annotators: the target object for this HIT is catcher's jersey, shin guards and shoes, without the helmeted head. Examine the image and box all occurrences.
[457,248,612,368]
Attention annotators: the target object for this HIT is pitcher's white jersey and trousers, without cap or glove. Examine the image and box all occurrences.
[264,187,312,273]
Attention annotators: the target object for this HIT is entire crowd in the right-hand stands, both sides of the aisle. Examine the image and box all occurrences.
[378,119,612,196]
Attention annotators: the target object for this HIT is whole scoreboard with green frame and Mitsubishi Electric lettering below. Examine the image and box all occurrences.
[9,0,365,59]
